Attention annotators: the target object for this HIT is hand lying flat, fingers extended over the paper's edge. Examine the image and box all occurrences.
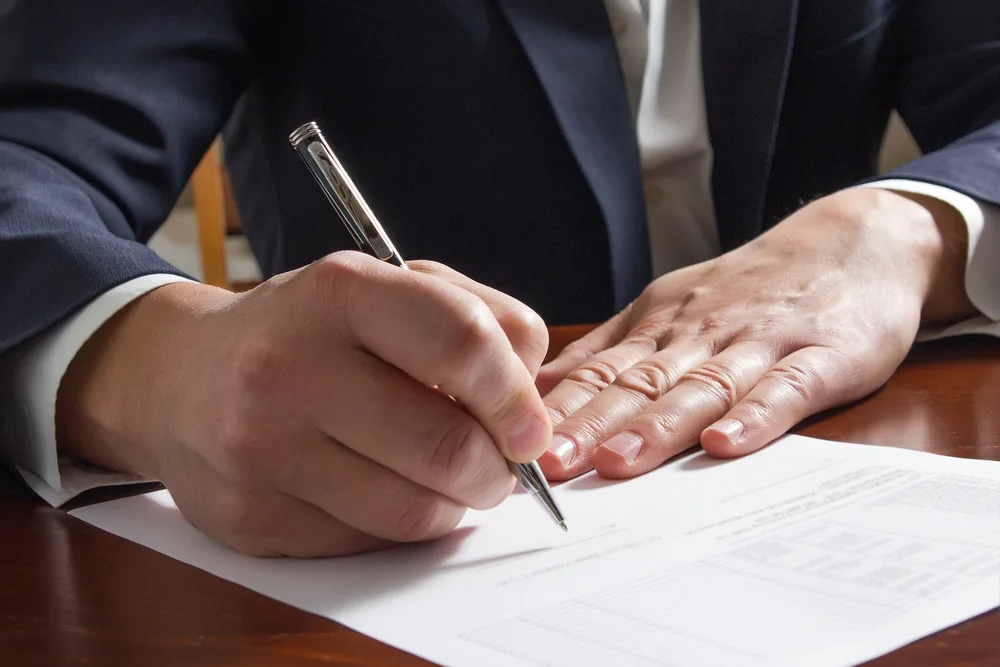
[538,189,976,479]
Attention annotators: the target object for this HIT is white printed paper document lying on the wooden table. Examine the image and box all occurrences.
[72,436,1000,667]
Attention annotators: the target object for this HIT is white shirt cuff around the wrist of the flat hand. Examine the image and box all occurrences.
[857,179,1000,340]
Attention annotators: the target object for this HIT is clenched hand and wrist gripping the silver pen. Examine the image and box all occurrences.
[57,252,551,557]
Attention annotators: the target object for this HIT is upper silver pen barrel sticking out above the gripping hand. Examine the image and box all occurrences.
[288,122,406,268]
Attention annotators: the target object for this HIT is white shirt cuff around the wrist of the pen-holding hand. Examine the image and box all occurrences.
[0,274,191,507]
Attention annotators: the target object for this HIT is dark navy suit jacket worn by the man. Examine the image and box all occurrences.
[0,0,1000,496]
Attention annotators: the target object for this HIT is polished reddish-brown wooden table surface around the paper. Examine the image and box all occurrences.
[0,327,1000,667]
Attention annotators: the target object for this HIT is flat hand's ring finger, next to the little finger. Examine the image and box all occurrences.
[591,342,780,478]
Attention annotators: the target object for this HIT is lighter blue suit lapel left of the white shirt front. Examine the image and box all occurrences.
[496,0,652,308]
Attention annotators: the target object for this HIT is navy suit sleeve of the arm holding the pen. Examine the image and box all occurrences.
[0,0,251,355]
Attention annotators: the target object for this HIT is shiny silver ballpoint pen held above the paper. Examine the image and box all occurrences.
[288,122,566,531]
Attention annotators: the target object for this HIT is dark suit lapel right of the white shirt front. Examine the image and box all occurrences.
[700,0,798,250]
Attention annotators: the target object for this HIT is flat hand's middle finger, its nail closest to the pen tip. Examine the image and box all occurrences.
[539,342,712,479]
